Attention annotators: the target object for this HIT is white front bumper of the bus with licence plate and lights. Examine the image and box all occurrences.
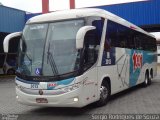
[16,87,86,107]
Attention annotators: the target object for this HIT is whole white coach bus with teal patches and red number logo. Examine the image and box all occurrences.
[4,8,157,107]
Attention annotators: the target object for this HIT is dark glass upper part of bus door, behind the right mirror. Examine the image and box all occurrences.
[84,17,104,69]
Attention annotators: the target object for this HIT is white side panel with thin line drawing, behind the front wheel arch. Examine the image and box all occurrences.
[98,47,130,94]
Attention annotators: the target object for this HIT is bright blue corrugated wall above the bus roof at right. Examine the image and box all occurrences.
[97,0,160,25]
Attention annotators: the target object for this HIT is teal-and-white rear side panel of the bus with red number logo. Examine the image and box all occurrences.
[126,49,156,87]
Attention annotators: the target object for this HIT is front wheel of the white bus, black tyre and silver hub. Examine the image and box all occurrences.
[97,82,110,107]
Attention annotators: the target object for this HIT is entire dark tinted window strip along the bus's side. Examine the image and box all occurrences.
[105,20,157,51]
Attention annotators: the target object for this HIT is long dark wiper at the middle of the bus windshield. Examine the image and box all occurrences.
[47,43,58,76]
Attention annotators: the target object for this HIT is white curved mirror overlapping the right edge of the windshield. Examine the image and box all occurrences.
[76,26,96,49]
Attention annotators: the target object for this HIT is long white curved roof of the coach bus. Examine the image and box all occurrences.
[27,8,154,37]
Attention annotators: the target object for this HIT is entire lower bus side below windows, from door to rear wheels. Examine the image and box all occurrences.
[98,48,156,94]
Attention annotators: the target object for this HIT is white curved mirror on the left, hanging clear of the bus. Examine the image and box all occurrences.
[3,32,22,53]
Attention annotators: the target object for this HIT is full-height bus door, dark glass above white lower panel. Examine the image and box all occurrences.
[80,18,104,102]
